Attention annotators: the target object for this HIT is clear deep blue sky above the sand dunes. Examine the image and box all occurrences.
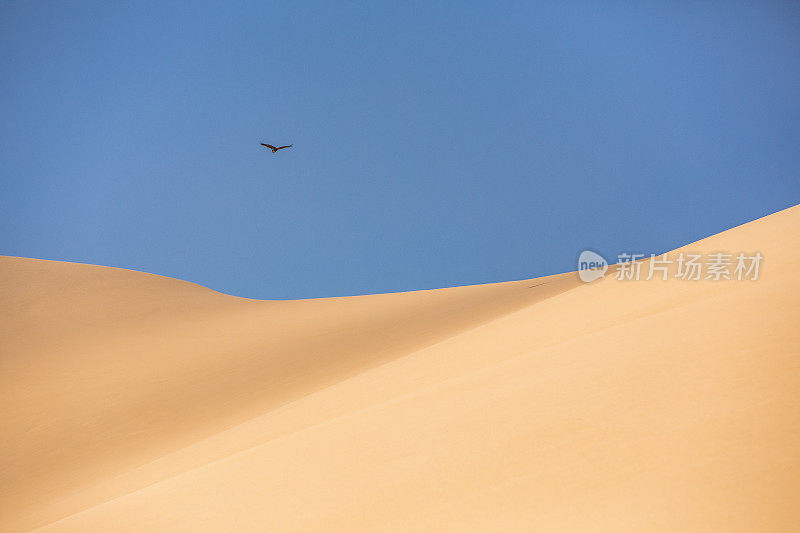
[0,0,800,298]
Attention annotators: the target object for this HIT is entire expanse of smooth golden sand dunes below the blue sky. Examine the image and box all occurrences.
[0,207,800,531]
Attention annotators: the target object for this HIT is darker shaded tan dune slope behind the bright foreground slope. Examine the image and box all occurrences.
[0,257,578,524]
